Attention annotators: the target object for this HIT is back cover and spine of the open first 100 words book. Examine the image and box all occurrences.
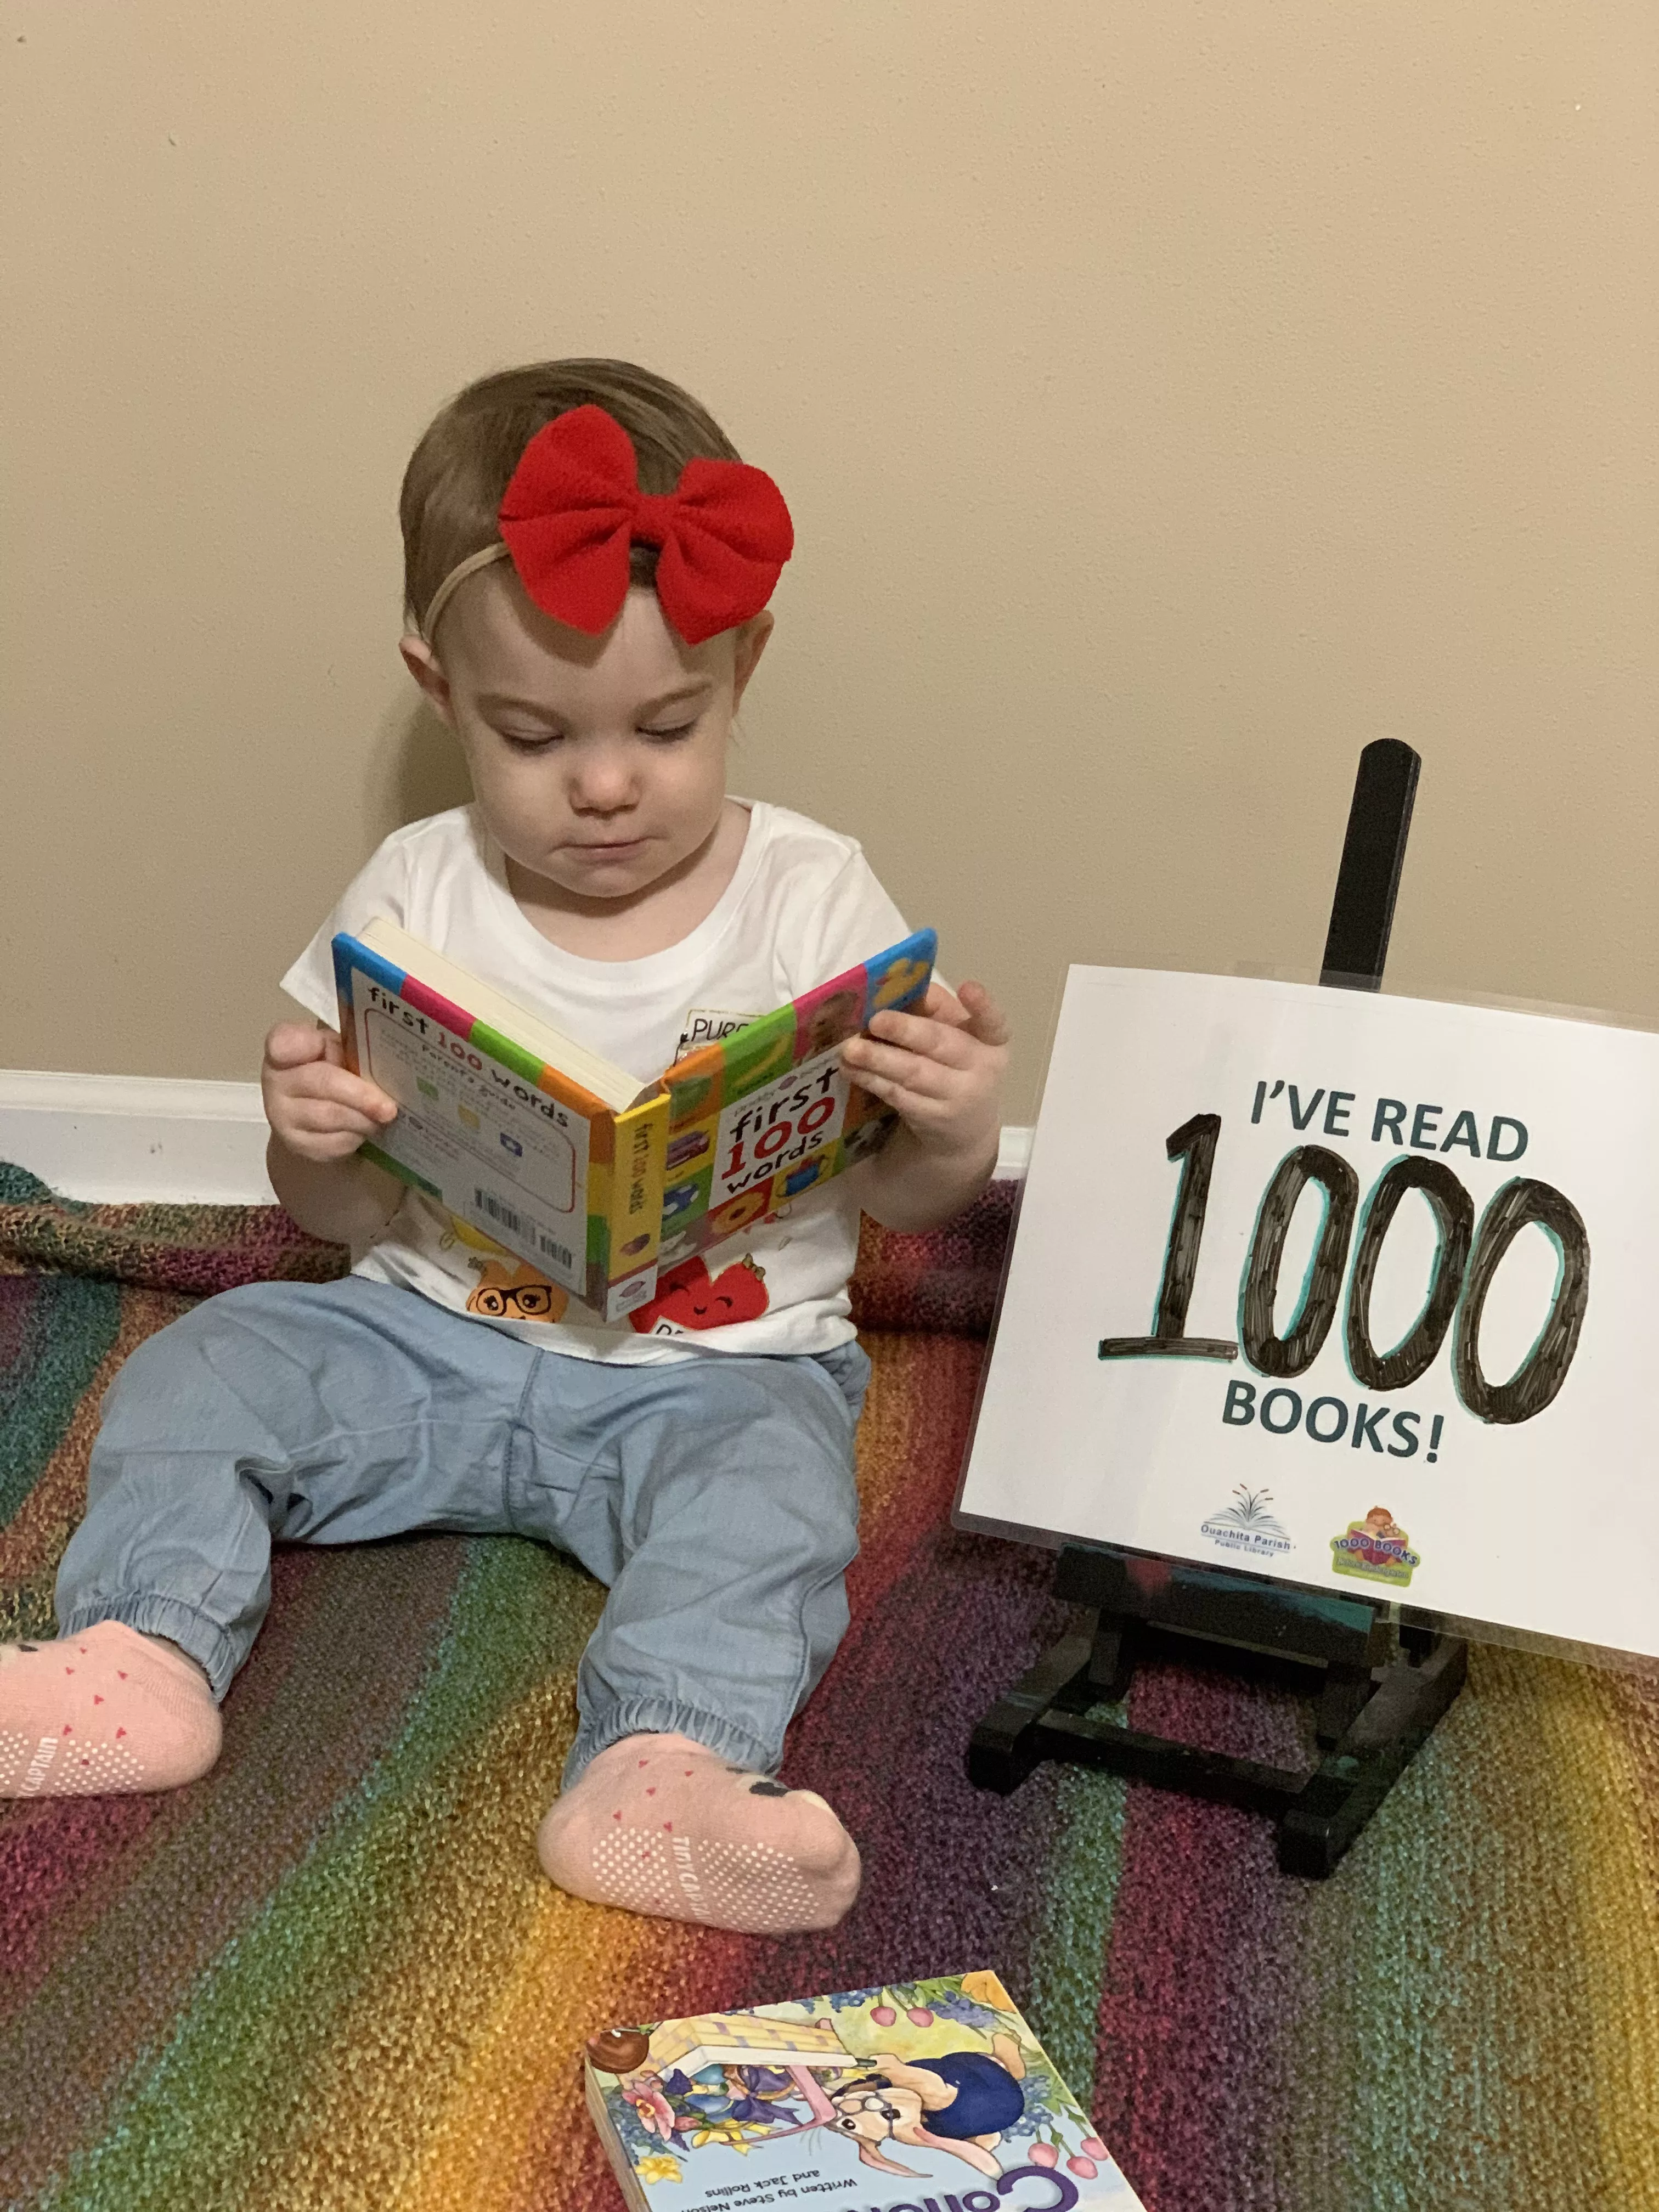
[334,934,668,1321]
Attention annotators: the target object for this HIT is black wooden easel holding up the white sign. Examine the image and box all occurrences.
[969,739,1469,1876]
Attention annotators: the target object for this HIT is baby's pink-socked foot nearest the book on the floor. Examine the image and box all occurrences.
[538,1736,860,1936]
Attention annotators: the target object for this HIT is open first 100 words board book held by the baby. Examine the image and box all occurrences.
[334,916,938,1321]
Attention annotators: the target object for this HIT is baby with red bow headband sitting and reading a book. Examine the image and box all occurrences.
[0,360,1007,1933]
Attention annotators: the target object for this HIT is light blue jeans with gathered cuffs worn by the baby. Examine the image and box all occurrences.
[58,1276,870,1783]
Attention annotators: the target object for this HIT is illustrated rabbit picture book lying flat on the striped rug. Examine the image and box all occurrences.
[586,1973,1139,2212]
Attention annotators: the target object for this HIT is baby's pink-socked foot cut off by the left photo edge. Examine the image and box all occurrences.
[0,1621,223,1798]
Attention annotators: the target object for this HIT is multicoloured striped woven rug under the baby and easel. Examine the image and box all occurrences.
[0,1168,1659,2212]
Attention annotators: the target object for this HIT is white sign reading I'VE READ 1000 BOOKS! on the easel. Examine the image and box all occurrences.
[958,967,1659,1655]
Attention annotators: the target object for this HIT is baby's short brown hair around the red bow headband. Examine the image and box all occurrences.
[398,360,743,630]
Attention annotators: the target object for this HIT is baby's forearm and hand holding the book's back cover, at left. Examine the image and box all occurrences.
[261,1022,403,1252]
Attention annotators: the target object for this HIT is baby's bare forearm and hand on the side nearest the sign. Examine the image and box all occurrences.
[840,982,1009,1230]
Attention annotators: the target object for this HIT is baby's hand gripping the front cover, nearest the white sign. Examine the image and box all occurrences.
[840,982,1009,1157]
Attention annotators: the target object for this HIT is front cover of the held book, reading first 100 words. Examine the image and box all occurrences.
[659,929,938,1267]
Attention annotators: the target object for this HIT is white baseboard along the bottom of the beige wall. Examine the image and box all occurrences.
[0,1068,1031,1205]
